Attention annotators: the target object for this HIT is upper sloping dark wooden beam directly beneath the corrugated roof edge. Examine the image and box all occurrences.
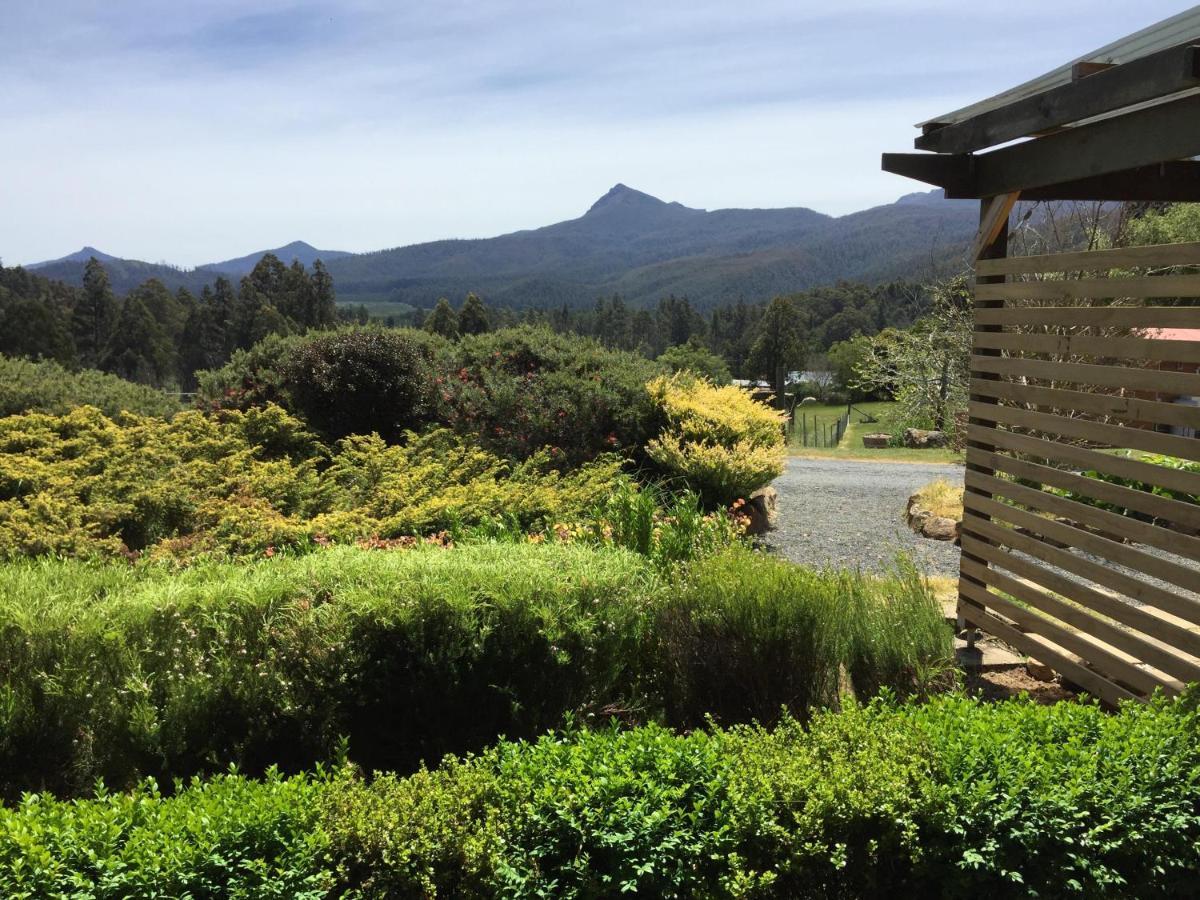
[914,46,1200,153]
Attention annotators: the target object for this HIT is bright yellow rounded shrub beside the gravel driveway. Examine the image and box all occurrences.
[646,374,785,505]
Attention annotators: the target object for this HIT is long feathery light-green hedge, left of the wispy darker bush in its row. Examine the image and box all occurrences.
[0,544,655,797]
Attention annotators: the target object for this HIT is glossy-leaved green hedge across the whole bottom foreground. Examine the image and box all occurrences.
[0,696,1200,898]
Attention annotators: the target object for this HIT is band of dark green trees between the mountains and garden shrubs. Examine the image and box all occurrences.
[0,253,930,390]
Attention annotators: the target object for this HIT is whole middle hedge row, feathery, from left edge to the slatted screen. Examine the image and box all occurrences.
[0,542,949,798]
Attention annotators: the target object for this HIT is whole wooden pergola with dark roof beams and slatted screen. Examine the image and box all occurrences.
[883,7,1200,702]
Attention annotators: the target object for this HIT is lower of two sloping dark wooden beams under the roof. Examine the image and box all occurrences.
[974,89,1200,197]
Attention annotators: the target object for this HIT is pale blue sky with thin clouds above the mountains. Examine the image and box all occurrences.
[0,0,1187,266]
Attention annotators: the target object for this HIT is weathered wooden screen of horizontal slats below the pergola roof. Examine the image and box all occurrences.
[959,244,1200,703]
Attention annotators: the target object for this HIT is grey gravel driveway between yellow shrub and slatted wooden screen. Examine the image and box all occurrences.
[767,457,962,576]
